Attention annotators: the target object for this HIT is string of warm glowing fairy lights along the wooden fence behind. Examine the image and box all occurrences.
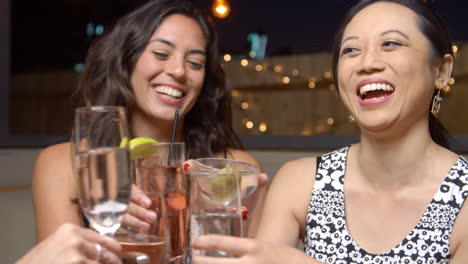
[223,45,459,135]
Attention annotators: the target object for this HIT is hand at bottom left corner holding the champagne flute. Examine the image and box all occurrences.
[17,224,121,264]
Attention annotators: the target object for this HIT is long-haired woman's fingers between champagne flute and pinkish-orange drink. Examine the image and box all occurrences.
[122,184,156,230]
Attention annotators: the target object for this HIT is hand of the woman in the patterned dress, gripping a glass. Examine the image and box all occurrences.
[192,235,320,264]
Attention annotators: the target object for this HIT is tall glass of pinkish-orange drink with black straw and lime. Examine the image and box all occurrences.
[134,142,188,264]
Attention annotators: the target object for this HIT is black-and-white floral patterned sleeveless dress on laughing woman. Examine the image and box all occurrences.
[304,147,468,264]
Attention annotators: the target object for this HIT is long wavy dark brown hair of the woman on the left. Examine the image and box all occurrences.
[79,0,242,158]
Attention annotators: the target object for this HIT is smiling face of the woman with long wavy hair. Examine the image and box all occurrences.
[131,14,206,120]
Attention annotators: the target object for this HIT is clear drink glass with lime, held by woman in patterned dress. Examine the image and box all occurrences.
[190,158,258,257]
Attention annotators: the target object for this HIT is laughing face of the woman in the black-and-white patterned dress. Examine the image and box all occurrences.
[338,2,437,132]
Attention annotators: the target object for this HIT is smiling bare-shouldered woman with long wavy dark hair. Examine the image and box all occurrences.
[33,0,267,245]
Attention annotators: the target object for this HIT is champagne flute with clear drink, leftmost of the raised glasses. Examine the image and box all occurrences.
[72,106,133,236]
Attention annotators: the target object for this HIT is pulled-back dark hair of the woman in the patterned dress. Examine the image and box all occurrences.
[332,0,453,149]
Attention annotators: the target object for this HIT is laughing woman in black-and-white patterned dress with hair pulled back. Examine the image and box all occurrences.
[192,0,468,264]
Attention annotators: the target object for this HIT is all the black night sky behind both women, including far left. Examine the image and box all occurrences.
[11,0,468,73]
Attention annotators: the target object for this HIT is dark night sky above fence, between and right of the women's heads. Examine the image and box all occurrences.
[209,0,468,54]
